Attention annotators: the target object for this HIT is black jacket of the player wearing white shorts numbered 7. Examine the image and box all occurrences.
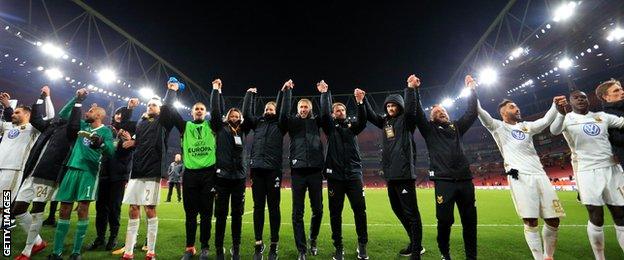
[130,95,173,179]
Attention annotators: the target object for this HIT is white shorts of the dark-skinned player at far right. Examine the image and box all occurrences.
[575,164,624,206]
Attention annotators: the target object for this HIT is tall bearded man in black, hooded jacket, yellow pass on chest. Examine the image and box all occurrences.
[365,76,424,259]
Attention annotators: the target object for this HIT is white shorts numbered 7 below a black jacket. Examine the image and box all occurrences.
[123,178,160,206]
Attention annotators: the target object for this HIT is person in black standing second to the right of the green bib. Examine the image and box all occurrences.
[243,87,286,260]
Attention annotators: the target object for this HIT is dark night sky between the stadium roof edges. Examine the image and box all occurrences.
[86,0,506,95]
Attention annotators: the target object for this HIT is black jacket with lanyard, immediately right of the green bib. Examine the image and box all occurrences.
[210,90,251,180]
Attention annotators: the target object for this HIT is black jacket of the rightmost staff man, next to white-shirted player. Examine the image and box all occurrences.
[416,90,477,181]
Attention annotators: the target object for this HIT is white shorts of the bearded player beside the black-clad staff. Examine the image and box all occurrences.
[507,174,565,219]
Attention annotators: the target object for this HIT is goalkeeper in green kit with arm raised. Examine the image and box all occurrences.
[49,89,115,259]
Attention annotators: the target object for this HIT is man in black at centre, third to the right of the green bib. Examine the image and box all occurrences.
[279,80,324,259]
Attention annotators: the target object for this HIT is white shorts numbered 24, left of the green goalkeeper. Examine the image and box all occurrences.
[15,176,56,203]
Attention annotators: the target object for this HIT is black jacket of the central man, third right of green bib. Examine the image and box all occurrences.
[279,89,324,170]
